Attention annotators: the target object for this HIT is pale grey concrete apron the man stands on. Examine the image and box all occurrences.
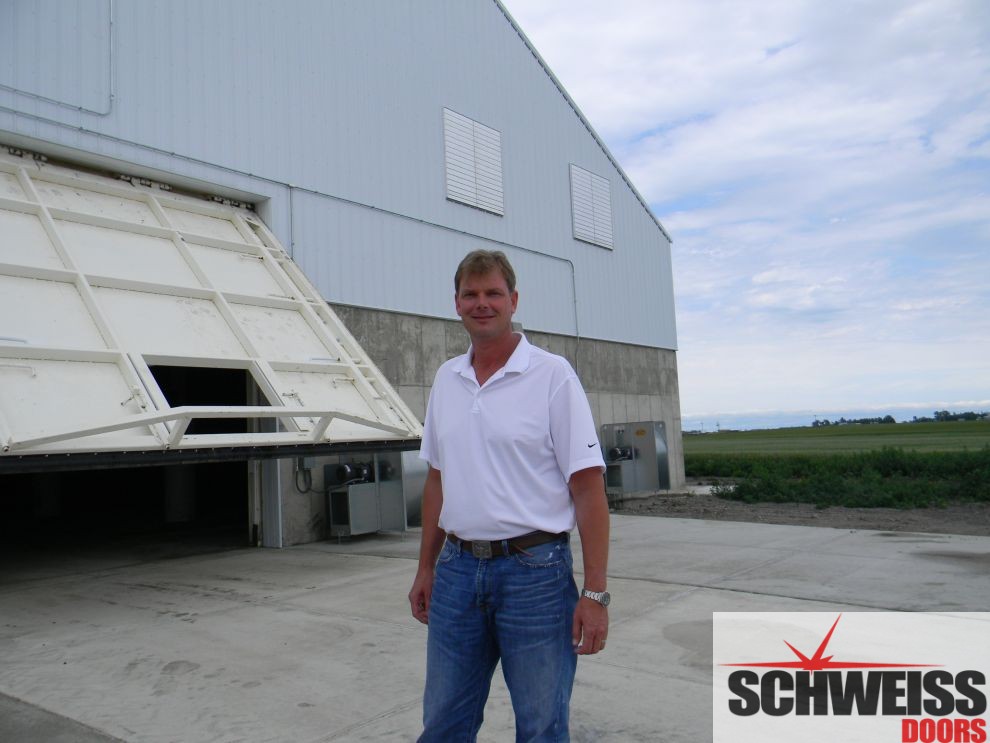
[0,515,990,743]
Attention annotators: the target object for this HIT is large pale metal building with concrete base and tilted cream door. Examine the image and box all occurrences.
[0,0,683,546]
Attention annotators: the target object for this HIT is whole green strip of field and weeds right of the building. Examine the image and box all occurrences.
[684,421,990,508]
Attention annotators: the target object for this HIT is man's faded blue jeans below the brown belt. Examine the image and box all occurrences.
[419,538,578,743]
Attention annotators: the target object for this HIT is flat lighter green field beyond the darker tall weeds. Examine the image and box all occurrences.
[684,421,990,456]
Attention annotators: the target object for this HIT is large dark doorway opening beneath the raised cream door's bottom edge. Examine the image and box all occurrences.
[0,461,252,582]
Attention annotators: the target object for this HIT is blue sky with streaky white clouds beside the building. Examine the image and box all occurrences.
[503,0,990,430]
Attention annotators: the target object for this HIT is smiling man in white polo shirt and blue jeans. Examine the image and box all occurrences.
[409,250,609,743]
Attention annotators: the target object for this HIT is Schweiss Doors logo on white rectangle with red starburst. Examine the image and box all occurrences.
[712,612,990,743]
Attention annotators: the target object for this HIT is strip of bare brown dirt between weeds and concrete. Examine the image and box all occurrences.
[613,482,990,537]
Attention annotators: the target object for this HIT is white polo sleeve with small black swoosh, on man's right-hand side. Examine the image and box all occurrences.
[550,370,605,481]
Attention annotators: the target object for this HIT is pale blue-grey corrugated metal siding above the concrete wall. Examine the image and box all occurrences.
[0,0,676,348]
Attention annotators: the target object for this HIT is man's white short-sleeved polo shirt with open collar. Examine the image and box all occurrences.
[419,334,605,540]
